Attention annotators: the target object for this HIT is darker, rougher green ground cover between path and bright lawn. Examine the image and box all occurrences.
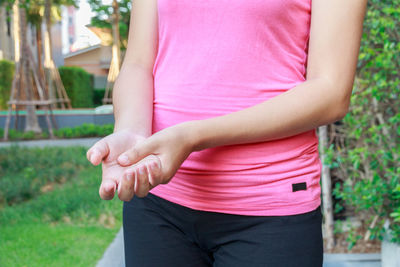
[0,147,89,206]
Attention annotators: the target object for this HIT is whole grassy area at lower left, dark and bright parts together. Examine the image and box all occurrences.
[0,148,122,266]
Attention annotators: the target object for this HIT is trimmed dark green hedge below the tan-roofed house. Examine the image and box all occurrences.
[59,66,94,108]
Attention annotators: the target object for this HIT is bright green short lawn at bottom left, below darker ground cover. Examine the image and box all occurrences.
[0,148,122,267]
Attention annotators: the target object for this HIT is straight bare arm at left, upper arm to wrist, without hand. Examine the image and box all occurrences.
[113,0,158,136]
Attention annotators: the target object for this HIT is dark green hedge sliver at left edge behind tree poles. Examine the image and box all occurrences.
[0,60,14,109]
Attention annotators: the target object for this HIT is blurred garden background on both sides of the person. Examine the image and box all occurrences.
[0,0,400,267]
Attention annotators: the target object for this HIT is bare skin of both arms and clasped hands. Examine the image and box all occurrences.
[88,0,367,201]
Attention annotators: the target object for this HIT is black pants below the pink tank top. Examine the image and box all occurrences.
[123,194,323,267]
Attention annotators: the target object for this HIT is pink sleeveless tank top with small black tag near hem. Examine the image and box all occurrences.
[151,0,322,215]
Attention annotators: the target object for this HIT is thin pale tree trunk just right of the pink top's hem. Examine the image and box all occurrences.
[318,125,335,250]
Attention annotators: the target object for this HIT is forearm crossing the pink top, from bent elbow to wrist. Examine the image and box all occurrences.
[186,79,348,151]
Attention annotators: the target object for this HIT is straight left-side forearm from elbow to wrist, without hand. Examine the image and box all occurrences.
[113,63,153,137]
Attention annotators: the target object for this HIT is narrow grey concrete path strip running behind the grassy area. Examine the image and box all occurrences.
[0,137,101,148]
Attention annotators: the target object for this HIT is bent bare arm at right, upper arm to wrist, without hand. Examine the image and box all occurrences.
[187,0,367,150]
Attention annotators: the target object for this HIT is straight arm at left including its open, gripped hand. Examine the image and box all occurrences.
[87,0,159,201]
